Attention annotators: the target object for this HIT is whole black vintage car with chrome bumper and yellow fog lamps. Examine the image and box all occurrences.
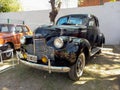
[17,14,105,80]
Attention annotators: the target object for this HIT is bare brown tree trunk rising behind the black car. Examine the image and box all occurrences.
[49,0,62,24]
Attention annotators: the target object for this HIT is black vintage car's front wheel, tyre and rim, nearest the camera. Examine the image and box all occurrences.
[69,53,85,80]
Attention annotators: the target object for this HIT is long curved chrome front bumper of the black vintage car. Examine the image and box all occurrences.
[20,59,70,73]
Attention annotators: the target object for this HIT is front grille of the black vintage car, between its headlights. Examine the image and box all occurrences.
[26,38,54,60]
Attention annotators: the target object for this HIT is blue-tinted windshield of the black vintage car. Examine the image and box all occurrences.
[57,15,87,25]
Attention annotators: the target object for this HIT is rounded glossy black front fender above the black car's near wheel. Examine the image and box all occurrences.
[55,38,90,64]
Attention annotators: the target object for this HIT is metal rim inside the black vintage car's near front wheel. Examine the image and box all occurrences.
[76,55,85,77]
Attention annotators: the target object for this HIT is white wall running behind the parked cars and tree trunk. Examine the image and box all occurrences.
[0,2,120,45]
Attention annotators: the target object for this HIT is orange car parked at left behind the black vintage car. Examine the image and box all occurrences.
[0,24,33,59]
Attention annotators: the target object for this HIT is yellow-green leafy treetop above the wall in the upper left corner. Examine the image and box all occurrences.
[0,0,21,12]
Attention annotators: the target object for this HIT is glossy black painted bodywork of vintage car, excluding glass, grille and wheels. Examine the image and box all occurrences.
[22,14,105,66]
